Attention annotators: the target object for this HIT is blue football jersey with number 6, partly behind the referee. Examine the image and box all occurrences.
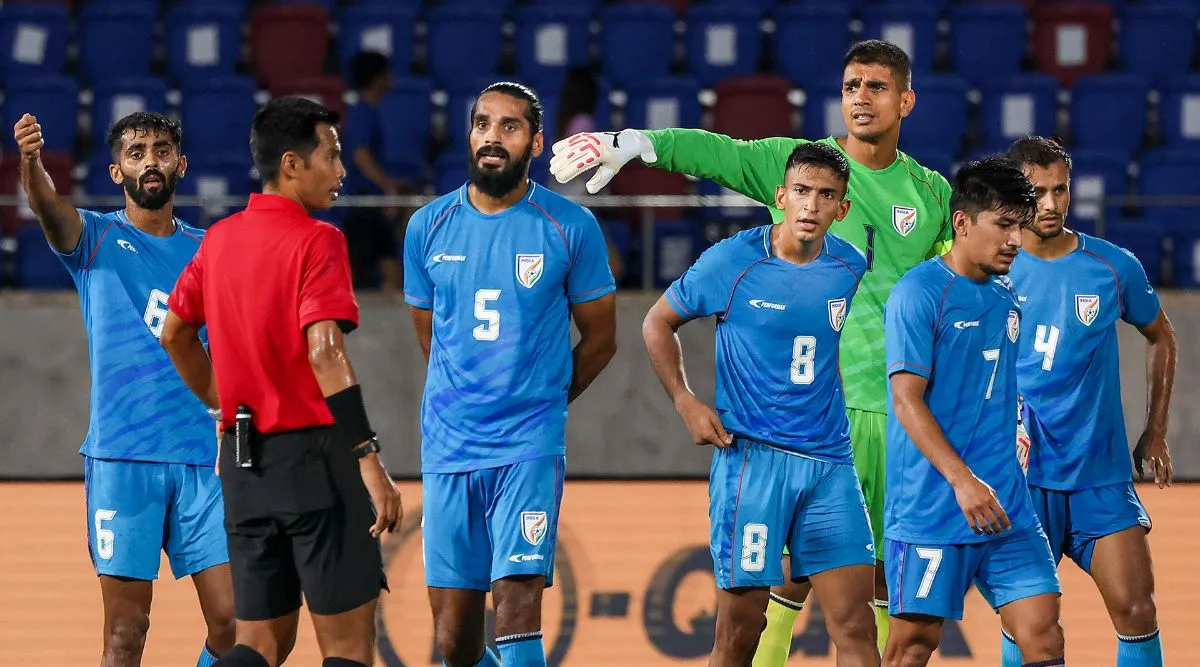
[59,209,216,465]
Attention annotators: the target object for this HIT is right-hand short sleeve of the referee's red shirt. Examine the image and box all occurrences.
[300,224,359,334]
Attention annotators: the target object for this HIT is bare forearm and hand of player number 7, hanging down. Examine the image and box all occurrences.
[889,371,1013,535]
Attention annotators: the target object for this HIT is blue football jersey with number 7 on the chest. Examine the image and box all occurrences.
[883,258,1037,545]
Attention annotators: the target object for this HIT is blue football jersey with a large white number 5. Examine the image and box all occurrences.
[404,181,616,473]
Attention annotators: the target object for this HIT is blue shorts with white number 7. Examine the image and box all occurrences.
[883,527,1061,620]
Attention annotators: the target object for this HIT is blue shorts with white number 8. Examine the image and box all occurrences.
[708,439,875,590]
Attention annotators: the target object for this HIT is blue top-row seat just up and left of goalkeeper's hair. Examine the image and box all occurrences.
[772,2,851,88]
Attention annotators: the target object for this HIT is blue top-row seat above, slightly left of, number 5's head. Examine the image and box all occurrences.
[426,6,502,90]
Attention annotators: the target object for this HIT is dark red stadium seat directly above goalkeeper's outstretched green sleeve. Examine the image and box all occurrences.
[713,74,792,139]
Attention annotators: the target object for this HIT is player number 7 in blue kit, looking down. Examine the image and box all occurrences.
[883,158,1064,667]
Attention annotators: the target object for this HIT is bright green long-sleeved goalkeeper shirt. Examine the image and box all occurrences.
[646,128,953,413]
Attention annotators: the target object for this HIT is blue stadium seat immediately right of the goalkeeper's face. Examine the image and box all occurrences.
[900,74,967,155]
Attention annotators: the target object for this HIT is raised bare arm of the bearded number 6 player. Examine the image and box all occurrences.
[13,114,83,254]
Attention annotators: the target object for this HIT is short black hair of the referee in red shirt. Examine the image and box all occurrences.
[250,97,342,184]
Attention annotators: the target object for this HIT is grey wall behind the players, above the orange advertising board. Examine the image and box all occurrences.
[0,292,1200,480]
